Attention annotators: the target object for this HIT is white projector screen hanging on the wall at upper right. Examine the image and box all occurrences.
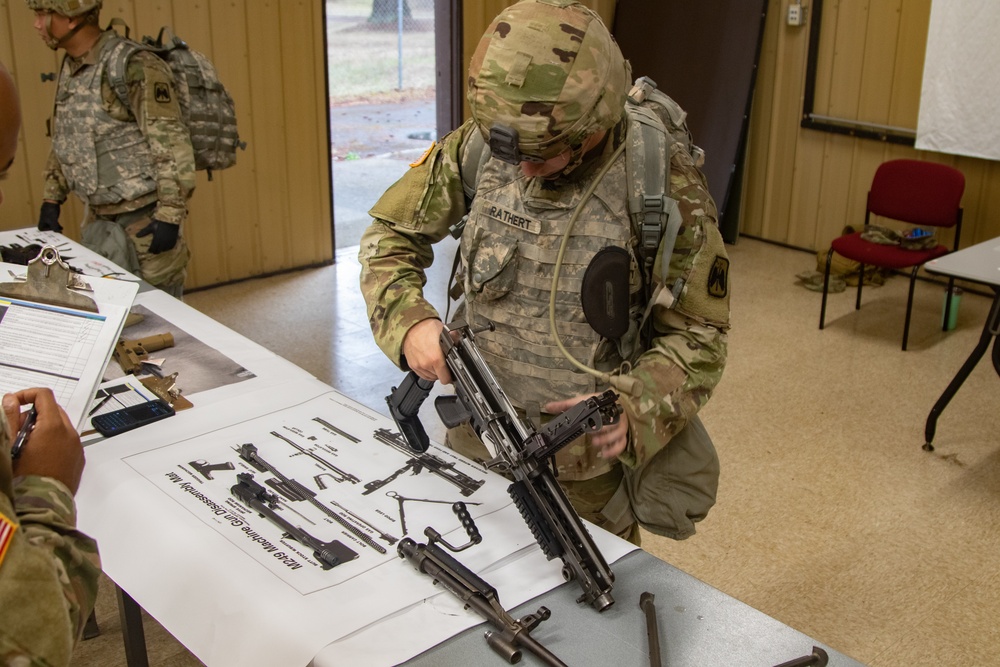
[916,0,1000,160]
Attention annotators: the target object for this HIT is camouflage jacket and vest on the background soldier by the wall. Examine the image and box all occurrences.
[43,30,195,225]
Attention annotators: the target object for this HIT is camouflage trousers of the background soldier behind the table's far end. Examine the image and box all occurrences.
[81,204,191,299]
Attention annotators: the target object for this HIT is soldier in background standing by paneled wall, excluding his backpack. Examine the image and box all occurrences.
[27,0,195,298]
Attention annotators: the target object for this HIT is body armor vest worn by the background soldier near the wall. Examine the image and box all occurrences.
[52,37,156,206]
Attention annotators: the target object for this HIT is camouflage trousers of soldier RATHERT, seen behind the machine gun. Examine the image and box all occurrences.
[445,424,641,546]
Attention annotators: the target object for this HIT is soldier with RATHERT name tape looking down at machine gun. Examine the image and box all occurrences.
[359,0,729,543]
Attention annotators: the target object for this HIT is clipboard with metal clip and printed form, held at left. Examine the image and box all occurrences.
[0,246,139,430]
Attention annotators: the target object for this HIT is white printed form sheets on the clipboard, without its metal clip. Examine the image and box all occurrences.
[0,263,139,428]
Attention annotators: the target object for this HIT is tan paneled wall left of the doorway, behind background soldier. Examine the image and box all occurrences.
[0,0,333,289]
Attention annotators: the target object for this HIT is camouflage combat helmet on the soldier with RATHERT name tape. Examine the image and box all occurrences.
[468,0,632,164]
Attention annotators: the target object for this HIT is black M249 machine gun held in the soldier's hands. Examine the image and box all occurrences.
[386,322,620,611]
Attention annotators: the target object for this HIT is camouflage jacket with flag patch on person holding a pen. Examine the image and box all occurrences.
[0,415,101,667]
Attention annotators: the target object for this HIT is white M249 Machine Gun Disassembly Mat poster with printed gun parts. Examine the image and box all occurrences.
[123,393,498,595]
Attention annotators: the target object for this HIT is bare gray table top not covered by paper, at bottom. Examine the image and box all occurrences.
[403,551,862,667]
